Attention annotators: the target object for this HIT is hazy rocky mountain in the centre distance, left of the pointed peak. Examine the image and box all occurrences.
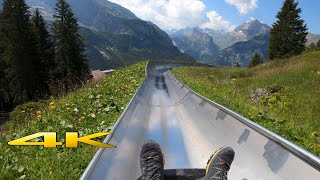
[170,28,219,60]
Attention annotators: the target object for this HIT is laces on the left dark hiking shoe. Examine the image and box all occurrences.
[142,156,161,180]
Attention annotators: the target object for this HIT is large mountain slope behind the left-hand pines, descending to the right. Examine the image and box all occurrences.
[21,0,191,69]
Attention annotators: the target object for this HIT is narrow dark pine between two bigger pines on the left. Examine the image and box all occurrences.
[32,9,54,94]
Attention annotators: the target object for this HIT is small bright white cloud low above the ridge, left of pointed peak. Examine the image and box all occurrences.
[201,11,235,31]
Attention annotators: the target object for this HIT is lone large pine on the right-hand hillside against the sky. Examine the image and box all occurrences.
[269,0,308,59]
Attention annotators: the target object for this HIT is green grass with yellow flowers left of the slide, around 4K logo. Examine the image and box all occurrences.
[0,63,145,179]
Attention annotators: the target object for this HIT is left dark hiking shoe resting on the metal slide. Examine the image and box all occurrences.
[140,141,164,180]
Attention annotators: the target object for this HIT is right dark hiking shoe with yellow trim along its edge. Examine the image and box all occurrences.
[201,147,235,180]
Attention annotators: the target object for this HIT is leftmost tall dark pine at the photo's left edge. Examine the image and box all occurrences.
[1,0,40,106]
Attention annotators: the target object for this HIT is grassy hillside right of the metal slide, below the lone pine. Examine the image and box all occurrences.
[174,51,320,156]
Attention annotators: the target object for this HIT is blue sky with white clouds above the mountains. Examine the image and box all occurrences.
[110,0,320,34]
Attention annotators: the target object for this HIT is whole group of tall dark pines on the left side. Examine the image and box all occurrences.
[0,0,89,111]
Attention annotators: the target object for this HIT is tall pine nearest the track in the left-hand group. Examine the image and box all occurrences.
[53,0,89,91]
